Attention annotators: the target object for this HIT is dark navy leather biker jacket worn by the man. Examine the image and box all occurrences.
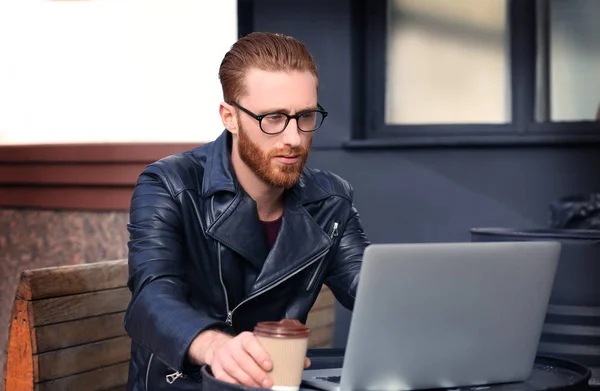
[125,131,369,391]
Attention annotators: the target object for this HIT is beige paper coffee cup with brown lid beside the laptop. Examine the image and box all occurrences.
[254,319,310,391]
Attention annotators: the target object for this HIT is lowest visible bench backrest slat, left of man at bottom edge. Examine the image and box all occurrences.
[36,362,129,391]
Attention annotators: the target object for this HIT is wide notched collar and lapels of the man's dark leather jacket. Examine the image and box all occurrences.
[202,130,332,292]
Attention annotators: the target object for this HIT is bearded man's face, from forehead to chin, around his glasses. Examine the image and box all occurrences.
[237,69,317,188]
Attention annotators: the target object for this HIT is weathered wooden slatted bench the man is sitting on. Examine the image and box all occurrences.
[5,260,335,391]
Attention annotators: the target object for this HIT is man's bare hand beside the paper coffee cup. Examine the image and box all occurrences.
[189,331,273,388]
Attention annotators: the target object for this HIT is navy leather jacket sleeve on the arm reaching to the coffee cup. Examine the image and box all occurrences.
[125,166,227,371]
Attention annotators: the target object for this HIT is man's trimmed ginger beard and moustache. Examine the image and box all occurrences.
[238,123,312,189]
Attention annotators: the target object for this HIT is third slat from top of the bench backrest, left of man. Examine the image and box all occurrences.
[32,312,126,354]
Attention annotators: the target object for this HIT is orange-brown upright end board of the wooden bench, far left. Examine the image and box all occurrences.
[5,300,37,391]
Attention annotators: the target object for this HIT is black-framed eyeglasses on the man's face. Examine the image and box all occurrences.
[229,102,327,134]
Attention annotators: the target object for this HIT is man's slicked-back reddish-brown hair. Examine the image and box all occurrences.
[219,32,319,102]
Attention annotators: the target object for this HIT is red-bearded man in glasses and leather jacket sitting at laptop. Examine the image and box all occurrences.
[125,33,369,391]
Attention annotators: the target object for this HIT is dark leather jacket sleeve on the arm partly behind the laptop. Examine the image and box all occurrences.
[325,205,371,310]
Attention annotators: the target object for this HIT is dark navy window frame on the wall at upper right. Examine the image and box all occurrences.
[345,0,600,148]
